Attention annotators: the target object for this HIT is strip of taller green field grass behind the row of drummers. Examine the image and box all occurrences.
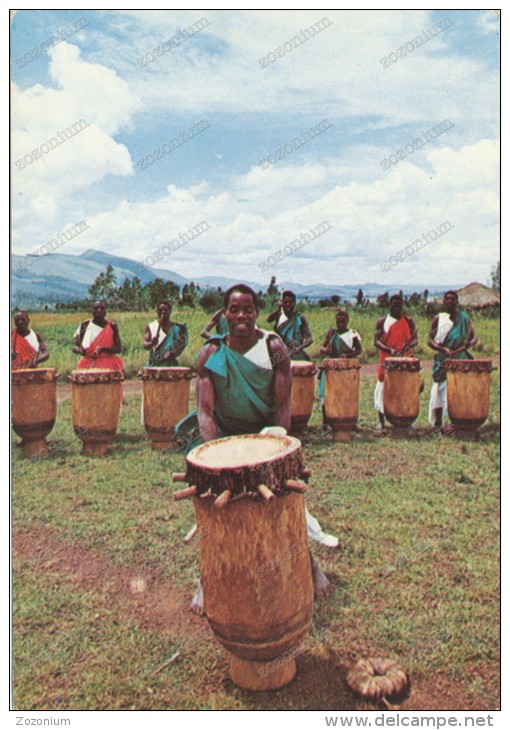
[22,309,500,377]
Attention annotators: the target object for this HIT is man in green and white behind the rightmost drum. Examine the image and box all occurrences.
[427,291,478,428]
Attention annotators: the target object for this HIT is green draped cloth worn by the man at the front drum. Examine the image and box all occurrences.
[176,335,275,453]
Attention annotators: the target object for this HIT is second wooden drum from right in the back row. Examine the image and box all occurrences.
[383,357,421,428]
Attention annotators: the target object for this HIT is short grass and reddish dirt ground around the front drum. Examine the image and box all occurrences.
[13,350,500,710]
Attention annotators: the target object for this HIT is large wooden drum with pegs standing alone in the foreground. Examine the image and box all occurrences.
[173,435,313,690]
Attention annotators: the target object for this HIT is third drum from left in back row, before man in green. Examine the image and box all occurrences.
[140,368,194,449]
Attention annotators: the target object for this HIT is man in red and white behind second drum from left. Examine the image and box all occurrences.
[73,300,124,370]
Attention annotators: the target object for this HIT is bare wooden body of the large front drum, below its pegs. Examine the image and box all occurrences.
[193,493,313,689]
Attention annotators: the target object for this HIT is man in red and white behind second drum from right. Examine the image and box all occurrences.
[374,294,418,431]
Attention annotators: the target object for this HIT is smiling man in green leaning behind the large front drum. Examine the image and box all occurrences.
[177,284,338,614]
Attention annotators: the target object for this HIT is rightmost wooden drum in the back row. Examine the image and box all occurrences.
[444,360,494,432]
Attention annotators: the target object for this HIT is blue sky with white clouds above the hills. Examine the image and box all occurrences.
[10,10,500,287]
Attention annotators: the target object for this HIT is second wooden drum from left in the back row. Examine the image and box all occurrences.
[69,368,124,456]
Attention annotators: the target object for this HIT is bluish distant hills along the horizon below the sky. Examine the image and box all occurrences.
[11,249,459,308]
